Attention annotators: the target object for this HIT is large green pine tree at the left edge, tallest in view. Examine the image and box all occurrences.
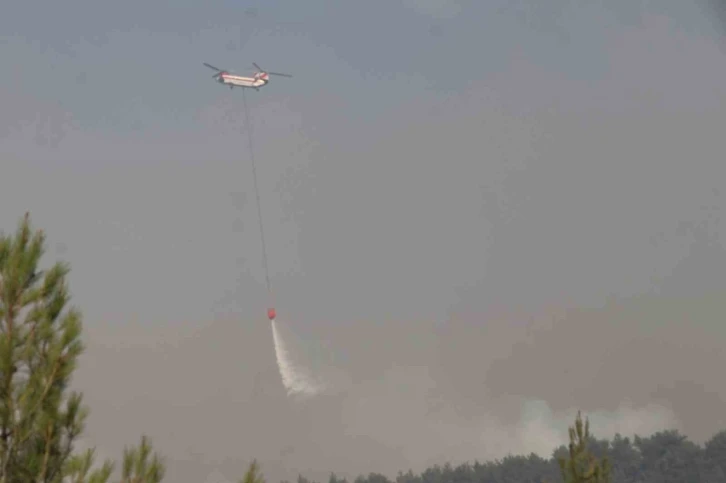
[0,213,163,483]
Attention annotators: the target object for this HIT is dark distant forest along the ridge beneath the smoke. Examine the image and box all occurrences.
[292,431,726,483]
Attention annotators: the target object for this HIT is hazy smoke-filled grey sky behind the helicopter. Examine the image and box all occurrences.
[0,0,726,482]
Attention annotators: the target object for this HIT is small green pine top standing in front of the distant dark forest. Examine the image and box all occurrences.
[558,411,611,483]
